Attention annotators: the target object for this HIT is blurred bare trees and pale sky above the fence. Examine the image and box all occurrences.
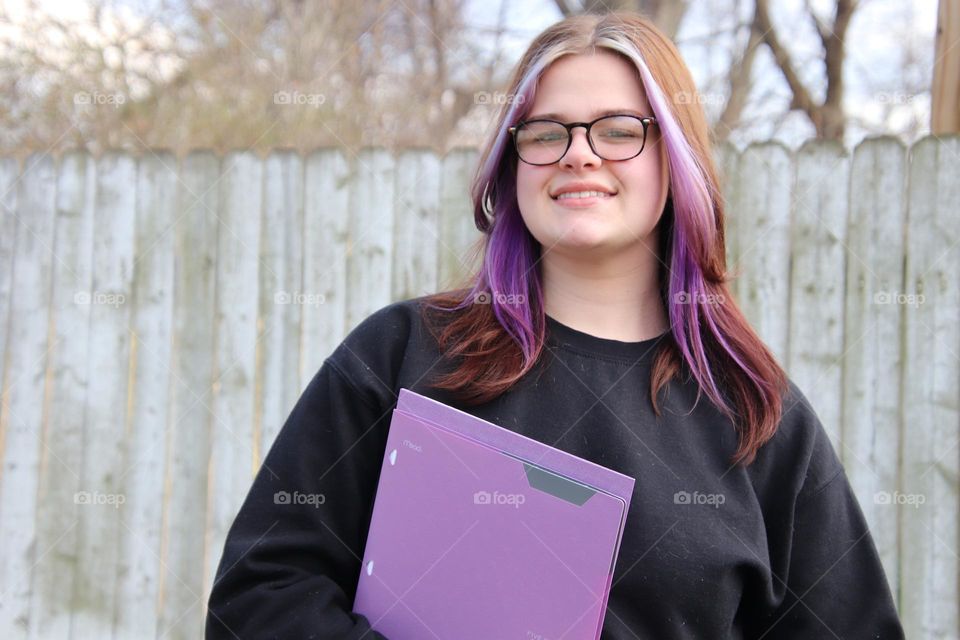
[0,0,960,155]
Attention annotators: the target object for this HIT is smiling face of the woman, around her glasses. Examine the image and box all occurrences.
[517,51,667,258]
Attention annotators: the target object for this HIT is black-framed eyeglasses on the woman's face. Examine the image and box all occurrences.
[507,115,657,166]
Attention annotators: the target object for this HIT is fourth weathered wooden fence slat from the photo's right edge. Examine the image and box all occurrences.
[735,143,794,366]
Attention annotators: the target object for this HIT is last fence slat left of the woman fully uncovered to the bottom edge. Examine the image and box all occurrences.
[161,152,220,640]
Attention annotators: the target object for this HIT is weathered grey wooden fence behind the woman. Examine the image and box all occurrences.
[0,138,960,640]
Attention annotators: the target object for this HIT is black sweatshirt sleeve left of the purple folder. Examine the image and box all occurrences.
[206,358,390,640]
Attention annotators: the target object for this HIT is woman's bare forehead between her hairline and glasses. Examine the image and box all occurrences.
[527,50,650,120]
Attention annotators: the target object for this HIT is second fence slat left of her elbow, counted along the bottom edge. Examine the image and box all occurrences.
[114,153,177,639]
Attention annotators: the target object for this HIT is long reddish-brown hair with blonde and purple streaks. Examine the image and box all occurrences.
[422,12,787,465]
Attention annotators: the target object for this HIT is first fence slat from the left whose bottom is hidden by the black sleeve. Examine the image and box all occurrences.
[203,152,269,604]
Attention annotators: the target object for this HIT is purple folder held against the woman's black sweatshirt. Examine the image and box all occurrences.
[353,389,634,640]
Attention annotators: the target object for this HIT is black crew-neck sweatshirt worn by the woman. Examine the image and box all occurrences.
[207,299,903,640]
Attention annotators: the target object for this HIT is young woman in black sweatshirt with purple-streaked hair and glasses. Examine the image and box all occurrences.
[207,14,903,640]
